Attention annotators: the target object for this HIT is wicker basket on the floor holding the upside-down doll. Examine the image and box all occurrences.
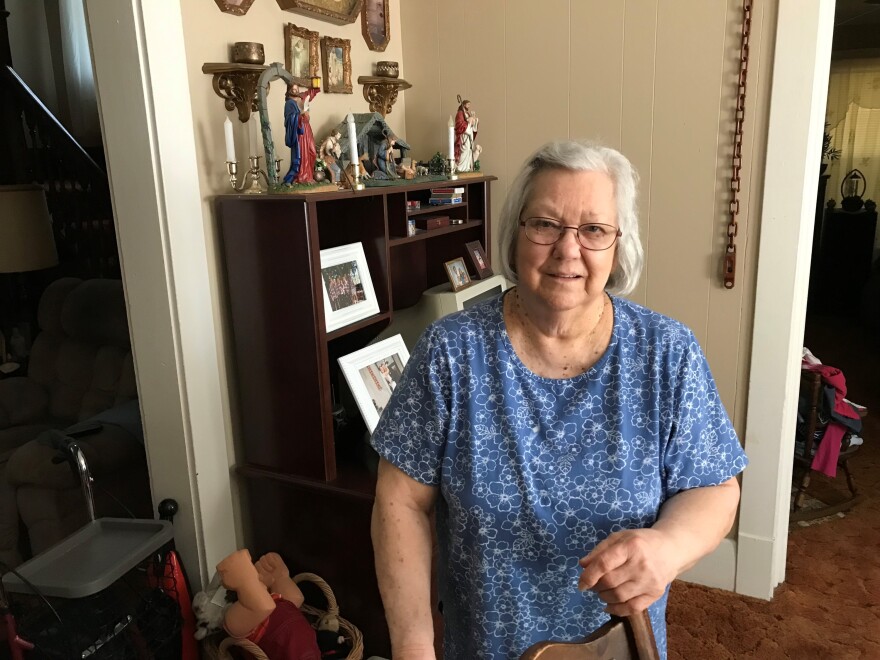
[202,573,364,660]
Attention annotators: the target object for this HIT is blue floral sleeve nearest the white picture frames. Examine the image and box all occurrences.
[370,326,451,486]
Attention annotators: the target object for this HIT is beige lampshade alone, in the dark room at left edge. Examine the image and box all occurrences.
[0,185,58,273]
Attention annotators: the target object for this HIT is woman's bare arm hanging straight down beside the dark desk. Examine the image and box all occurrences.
[372,458,437,660]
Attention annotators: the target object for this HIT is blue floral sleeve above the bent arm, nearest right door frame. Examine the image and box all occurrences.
[663,331,748,497]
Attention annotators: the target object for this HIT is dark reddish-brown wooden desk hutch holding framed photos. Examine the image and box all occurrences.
[215,176,495,657]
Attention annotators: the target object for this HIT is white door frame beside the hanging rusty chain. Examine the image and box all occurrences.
[736,0,834,599]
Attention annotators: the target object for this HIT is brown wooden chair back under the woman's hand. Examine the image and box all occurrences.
[521,610,660,660]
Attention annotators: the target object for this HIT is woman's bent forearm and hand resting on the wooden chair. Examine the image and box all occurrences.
[578,477,739,616]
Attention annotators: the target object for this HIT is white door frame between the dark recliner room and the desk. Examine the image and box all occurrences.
[85,0,236,589]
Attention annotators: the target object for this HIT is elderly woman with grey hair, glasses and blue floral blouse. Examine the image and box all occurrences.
[372,142,746,660]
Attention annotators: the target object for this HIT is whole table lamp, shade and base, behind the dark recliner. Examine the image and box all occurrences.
[0,185,58,364]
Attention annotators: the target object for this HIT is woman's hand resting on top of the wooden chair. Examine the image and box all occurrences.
[578,529,679,616]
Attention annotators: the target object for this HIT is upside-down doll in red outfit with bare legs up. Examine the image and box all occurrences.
[217,550,321,660]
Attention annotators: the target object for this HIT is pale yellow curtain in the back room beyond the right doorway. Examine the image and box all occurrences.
[825,59,880,211]
